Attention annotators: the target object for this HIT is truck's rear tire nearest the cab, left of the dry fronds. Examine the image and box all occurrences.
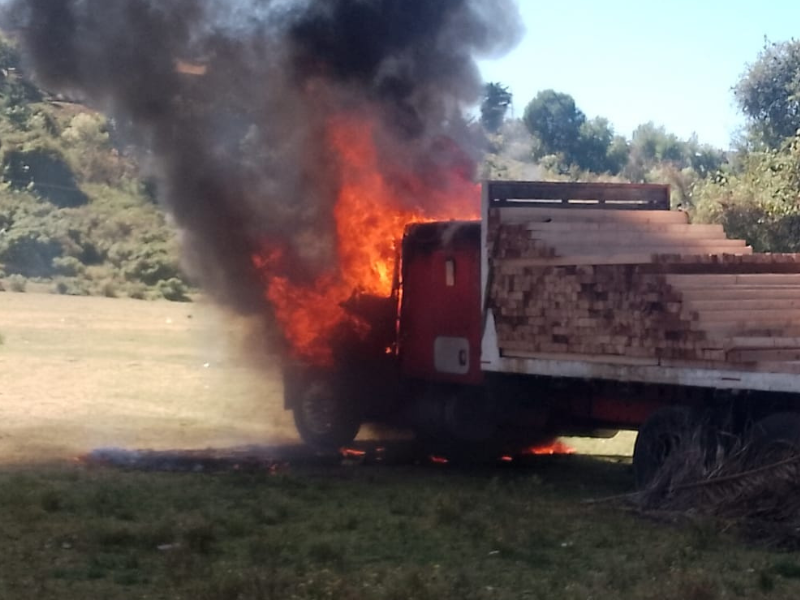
[633,406,692,489]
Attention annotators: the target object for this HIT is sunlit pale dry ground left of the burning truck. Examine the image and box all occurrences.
[0,293,294,462]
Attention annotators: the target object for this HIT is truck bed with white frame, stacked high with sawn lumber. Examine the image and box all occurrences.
[482,182,800,392]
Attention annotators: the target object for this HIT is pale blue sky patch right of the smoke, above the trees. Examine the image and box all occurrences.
[481,0,800,148]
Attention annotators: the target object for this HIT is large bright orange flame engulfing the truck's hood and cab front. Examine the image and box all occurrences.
[256,115,480,364]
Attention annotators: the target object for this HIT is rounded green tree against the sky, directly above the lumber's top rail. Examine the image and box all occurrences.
[522,90,586,163]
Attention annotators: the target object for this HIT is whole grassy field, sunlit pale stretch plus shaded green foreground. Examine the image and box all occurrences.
[0,293,800,600]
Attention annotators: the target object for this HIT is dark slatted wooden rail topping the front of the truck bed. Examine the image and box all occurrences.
[485,181,670,211]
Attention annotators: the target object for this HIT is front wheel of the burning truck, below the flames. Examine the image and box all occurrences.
[293,381,361,450]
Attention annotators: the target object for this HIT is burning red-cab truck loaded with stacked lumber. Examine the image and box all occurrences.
[285,181,800,485]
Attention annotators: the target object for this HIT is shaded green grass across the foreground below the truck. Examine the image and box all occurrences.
[0,456,800,600]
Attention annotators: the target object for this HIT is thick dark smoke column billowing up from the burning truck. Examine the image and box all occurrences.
[0,0,521,356]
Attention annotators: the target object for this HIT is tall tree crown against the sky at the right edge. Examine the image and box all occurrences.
[733,40,800,148]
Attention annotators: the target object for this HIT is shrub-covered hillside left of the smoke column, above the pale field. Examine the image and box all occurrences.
[0,38,189,300]
